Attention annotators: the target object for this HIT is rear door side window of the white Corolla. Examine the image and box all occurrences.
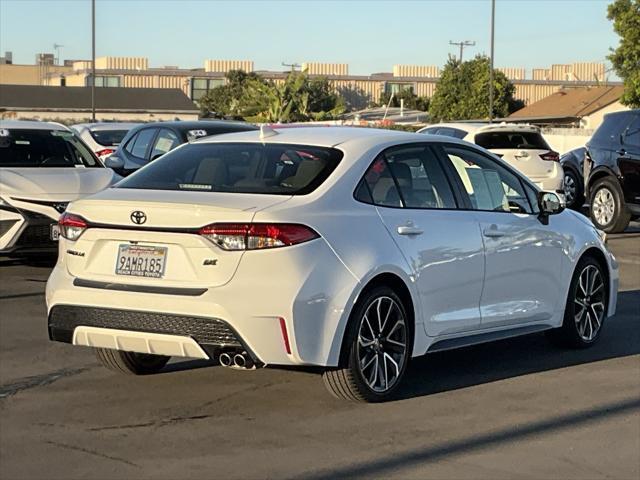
[356,145,456,209]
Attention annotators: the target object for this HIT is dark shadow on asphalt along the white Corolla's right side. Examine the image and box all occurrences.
[397,290,640,399]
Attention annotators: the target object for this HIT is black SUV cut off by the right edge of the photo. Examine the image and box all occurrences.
[584,110,640,233]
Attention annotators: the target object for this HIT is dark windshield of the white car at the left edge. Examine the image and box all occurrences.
[0,129,102,168]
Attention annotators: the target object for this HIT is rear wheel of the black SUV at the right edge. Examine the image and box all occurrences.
[589,177,631,233]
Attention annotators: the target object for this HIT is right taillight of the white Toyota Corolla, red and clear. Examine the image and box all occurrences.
[199,223,319,250]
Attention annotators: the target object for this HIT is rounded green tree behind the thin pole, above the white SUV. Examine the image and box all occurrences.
[429,55,518,121]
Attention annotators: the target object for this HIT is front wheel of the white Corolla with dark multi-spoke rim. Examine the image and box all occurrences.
[548,256,609,348]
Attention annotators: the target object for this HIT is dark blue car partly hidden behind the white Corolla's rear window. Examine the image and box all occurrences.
[105,120,258,176]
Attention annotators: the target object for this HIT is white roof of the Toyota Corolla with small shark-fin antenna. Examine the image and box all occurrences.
[194,126,448,147]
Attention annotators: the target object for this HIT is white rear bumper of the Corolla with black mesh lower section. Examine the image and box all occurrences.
[46,239,358,366]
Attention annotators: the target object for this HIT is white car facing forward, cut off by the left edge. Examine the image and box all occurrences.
[0,120,120,256]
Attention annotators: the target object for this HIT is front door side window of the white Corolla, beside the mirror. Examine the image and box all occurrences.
[444,146,533,213]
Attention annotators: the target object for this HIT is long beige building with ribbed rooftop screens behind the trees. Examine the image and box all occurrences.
[0,57,612,108]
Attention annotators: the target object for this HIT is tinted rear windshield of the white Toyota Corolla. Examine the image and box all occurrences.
[118,143,342,195]
